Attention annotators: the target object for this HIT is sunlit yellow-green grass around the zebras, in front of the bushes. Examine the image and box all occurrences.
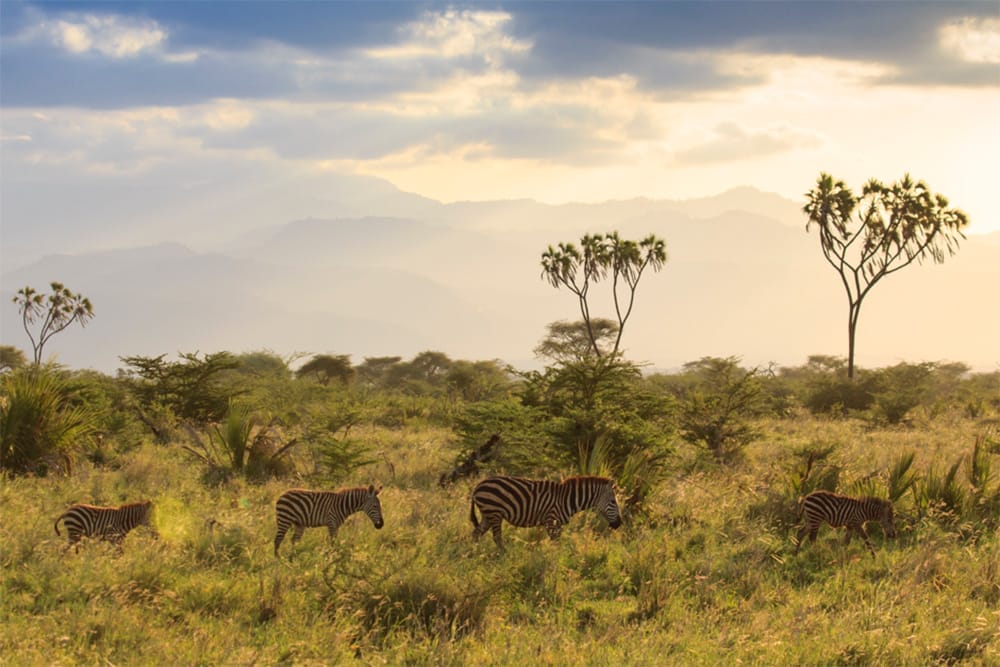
[0,416,1000,665]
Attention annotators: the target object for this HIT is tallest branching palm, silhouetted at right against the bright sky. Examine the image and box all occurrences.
[803,173,969,379]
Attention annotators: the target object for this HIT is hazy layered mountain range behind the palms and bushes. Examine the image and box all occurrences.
[0,187,1000,372]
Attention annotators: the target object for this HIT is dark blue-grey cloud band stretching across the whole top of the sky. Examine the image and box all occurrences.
[0,1,997,108]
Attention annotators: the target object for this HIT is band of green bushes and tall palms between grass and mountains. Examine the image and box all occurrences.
[0,174,984,507]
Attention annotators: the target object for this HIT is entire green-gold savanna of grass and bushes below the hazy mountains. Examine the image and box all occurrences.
[0,353,1000,665]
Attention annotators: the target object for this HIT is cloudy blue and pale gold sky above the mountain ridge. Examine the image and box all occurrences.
[0,0,1000,253]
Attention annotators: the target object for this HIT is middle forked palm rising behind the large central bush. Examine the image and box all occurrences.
[542,232,667,358]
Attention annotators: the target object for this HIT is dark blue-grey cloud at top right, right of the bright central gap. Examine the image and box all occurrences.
[513,1,998,88]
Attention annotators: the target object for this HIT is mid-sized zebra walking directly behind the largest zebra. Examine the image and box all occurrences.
[274,484,382,556]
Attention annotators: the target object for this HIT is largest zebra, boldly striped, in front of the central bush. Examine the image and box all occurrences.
[469,477,622,551]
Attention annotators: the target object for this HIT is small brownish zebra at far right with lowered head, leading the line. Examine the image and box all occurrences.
[795,491,896,558]
